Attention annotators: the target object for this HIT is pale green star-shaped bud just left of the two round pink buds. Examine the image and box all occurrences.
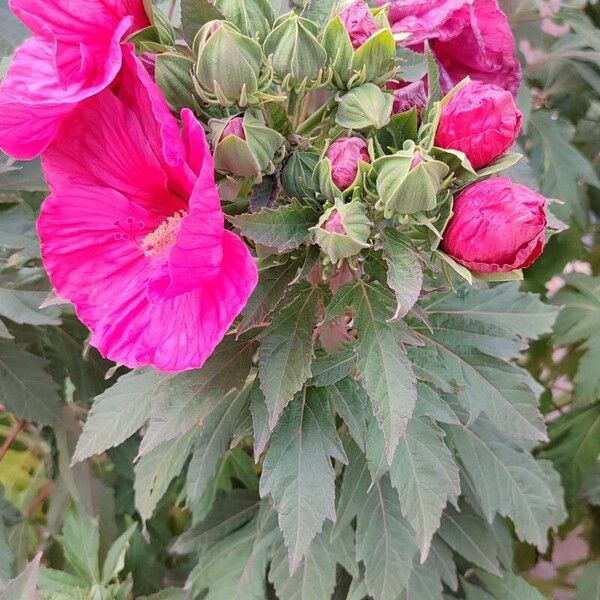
[373,141,449,219]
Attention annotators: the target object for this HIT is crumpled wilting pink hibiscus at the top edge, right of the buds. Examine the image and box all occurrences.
[378,0,521,95]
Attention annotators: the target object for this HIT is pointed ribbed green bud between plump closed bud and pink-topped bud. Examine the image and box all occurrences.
[264,13,327,89]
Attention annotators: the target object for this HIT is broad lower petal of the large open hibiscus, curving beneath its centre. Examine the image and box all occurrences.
[38,187,257,371]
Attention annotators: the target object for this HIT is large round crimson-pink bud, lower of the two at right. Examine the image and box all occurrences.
[441,177,547,273]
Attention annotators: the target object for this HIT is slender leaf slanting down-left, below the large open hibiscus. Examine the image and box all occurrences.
[186,387,250,506]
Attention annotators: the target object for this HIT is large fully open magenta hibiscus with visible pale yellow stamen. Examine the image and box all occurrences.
[38,46,257,371]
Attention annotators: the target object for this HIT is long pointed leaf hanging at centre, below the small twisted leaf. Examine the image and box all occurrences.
[327,281,417,462]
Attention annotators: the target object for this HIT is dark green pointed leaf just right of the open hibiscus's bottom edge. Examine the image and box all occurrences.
[258,284,321,429]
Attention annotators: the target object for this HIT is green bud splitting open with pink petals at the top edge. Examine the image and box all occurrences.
[323,0,396,89]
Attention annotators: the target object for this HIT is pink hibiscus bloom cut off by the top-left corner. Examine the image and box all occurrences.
[0,0,149,159]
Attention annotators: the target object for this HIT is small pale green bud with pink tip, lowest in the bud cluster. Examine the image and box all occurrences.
[311,200,371,264]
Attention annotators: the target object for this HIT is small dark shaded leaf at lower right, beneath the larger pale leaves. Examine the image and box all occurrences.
[438,507,500,575]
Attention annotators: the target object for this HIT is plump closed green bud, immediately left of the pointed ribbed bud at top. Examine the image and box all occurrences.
[194,21,264,106]
